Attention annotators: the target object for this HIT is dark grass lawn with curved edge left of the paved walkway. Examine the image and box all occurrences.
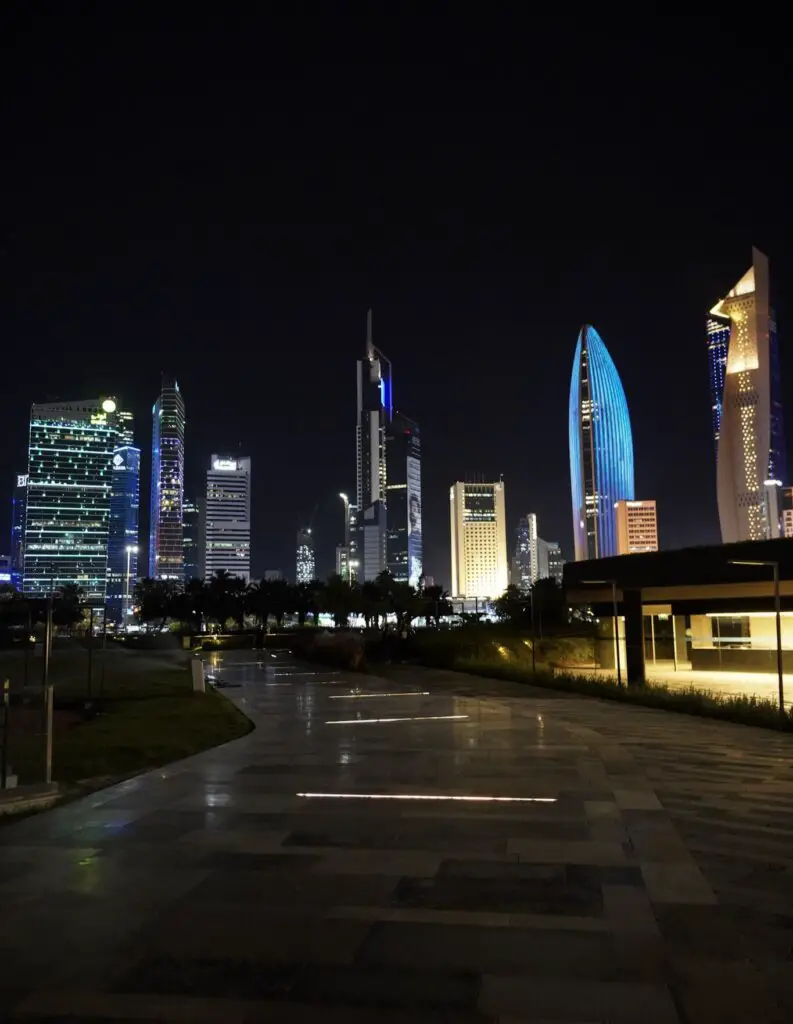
[2,651,252,783]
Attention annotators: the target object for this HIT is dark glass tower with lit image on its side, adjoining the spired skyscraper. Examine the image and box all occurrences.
[385,413,423,587]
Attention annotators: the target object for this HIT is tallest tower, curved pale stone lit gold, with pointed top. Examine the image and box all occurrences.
[707,249,787,544]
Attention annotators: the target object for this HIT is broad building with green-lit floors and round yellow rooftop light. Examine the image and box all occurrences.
[23,398,121,601]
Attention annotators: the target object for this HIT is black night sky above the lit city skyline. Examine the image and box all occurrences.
[0,14,793,585]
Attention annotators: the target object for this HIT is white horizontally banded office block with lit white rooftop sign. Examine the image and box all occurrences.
[204,455,251,583]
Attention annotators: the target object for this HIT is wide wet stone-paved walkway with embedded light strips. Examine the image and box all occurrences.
[0,653,793,1024]
